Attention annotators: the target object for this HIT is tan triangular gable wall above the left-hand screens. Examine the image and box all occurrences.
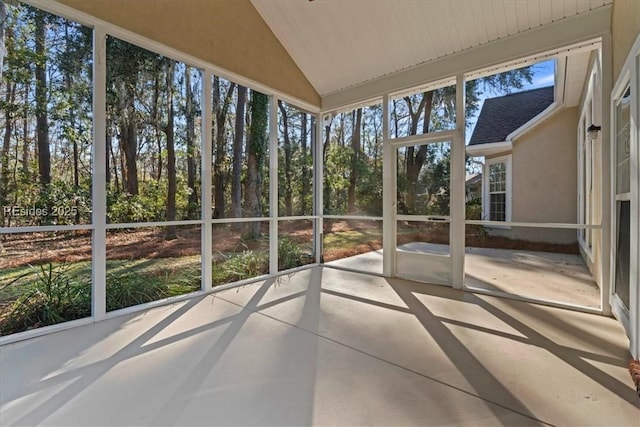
[58,0,320,106]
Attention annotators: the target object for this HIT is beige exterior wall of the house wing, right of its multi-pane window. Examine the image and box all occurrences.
[484,107,578,244]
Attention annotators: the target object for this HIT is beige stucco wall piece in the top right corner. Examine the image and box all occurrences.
[611,0,640,82]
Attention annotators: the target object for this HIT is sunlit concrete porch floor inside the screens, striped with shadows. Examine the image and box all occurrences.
[0,267,640,427]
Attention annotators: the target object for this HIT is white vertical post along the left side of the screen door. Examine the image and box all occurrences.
[382,94,397,277]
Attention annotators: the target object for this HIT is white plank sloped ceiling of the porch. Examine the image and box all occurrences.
[251,0,612,96]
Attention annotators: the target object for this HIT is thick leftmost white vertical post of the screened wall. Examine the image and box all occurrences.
[91,26,107,321]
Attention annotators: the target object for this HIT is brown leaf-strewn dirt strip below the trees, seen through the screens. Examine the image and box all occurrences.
[0,220,578,268]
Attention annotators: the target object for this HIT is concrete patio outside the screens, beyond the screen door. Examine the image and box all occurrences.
[327,246,600,308]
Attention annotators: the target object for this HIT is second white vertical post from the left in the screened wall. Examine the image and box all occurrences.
[200,70,213,291]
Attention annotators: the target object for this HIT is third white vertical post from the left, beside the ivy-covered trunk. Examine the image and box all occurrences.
[269,95,278,274]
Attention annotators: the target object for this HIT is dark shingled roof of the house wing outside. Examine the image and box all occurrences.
[469,86,554,145]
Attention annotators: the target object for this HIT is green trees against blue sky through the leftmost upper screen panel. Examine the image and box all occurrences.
[0,3,93,226]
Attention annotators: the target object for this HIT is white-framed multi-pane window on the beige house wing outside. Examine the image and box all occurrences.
[483,155,511,221]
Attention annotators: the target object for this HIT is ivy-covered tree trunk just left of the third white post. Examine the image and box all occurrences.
[245,92,269,238]
